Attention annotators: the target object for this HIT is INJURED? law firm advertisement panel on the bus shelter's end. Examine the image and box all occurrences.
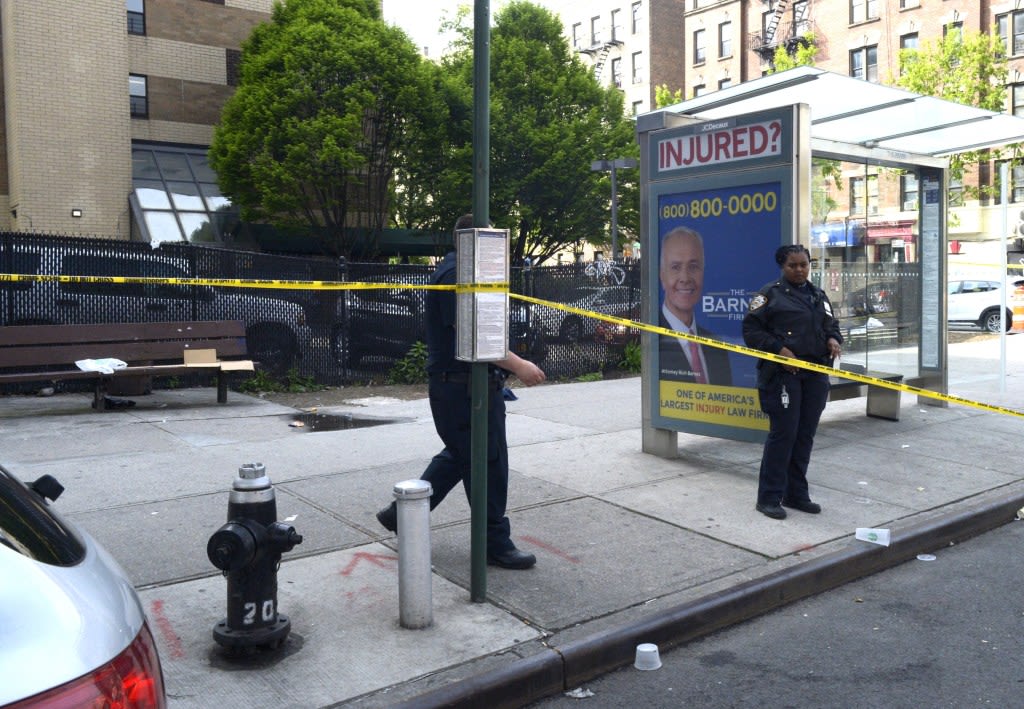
[642,106,810,441]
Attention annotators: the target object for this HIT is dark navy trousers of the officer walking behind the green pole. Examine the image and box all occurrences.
[421,378,514,554]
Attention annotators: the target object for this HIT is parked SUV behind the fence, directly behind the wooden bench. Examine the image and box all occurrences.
[0,246,312,375]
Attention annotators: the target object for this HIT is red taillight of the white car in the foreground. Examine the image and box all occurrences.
[7,624,167,709]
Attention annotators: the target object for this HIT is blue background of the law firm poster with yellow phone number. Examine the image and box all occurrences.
[654,181,783,388]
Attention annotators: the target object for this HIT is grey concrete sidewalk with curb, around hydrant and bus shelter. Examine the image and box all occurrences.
[0,338,1024,709]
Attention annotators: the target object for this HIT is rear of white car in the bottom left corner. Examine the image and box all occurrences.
[0,467,167,709]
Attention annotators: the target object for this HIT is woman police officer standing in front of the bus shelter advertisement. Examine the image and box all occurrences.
[743,244,843,519]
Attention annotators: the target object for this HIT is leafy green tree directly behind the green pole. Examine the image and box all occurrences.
[408,1,639,262]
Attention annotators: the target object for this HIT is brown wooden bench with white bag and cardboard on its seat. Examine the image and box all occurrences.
[0,320,254,410]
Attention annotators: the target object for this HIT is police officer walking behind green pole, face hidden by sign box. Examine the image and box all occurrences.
[377,214,545,569]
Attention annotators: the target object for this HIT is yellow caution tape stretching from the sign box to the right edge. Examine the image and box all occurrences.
[510,293,1024,418]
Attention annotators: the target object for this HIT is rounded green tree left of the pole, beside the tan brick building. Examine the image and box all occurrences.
[210,0,443,255]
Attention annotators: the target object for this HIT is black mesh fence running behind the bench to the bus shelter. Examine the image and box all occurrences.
[0,233,640,384]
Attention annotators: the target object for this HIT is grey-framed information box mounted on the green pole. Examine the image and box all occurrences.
[456,228,509,362]
